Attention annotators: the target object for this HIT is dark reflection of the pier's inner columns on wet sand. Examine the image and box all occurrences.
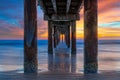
[48,53,76,73]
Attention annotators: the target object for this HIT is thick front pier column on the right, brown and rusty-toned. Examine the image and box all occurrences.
[84,0,98,74]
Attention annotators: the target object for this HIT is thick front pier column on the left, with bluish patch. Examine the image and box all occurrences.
[24,0,38,73]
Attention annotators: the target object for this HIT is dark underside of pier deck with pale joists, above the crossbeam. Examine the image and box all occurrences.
[39,0,83,15]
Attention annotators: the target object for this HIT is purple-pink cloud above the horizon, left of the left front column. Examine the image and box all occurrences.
[0,21,23,39]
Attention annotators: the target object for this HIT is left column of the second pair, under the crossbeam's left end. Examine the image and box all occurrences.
[48,21,53,54]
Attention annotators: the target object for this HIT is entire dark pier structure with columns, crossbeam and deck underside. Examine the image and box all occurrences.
[24,0,98,74]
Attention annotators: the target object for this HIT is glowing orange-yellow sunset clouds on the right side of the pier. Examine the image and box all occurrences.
[77,0,120,39]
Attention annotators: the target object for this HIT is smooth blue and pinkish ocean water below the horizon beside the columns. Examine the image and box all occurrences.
[0,40,120,72]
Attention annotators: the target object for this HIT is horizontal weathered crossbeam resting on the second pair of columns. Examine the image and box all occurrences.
[44,14,80,21]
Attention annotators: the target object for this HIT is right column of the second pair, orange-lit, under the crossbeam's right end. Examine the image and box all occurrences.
[71,21,76,54]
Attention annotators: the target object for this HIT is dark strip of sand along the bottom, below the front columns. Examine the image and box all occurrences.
[0,71,120,80]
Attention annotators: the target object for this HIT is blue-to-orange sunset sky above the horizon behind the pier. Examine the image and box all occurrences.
[0,0,120,39]
